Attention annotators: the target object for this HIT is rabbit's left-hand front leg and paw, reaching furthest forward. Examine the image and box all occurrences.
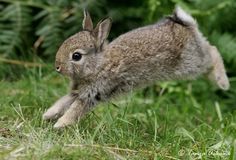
[43,94,75,120]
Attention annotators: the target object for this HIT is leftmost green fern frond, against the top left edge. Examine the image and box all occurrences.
[0,2,32,57]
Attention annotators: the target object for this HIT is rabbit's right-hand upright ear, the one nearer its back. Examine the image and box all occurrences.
[93,18,112,47]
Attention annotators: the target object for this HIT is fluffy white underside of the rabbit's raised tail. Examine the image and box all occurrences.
[172,6,197,26]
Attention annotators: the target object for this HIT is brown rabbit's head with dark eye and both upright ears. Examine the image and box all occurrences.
[55,11,111,78]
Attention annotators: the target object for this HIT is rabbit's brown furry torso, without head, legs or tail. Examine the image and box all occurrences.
[102,18,209,83]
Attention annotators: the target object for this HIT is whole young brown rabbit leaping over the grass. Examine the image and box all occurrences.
[43,7,229,128]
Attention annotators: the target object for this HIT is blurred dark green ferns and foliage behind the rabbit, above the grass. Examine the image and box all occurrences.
[0,0,236,109]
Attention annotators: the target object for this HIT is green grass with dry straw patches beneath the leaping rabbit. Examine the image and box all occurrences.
[0,65,236,160]
